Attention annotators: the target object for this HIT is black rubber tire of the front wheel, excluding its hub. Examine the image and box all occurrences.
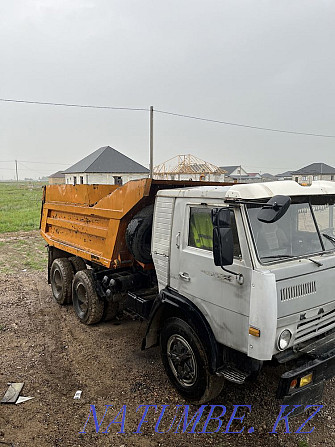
[160,317,224,405]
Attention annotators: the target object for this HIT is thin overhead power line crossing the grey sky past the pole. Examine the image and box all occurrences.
[0,98,335,138]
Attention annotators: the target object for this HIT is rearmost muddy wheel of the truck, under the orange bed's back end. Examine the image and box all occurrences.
[50,258,73,305]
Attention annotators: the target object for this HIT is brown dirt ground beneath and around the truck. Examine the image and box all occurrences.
[0,232,335,447]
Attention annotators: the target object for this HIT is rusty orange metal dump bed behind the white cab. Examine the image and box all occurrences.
[40,179,234,268]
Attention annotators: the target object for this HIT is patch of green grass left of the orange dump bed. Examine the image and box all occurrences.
[0,182,43,233]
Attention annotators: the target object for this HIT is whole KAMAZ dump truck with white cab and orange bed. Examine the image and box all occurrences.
[41,179,335,404]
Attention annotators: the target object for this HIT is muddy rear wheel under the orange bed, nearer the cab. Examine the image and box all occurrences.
[72,270,104,325]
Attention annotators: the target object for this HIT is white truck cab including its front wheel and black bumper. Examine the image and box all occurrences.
[148,181,335,404]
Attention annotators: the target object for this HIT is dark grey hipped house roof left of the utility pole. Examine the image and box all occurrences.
[64,146,149,174]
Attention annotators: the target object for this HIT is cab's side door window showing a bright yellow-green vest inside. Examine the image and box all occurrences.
[188,207,241,257]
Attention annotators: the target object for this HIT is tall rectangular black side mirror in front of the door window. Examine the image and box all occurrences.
[212,208,234,266]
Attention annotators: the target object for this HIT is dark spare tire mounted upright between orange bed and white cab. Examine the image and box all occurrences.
[126,205,154,264]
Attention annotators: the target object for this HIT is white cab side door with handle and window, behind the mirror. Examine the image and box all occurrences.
[170,198,251,318]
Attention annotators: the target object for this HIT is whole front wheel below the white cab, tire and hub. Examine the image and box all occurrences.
[160,318,224,404]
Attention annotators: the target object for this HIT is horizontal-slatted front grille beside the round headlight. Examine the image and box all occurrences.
[294,309,335,344]
